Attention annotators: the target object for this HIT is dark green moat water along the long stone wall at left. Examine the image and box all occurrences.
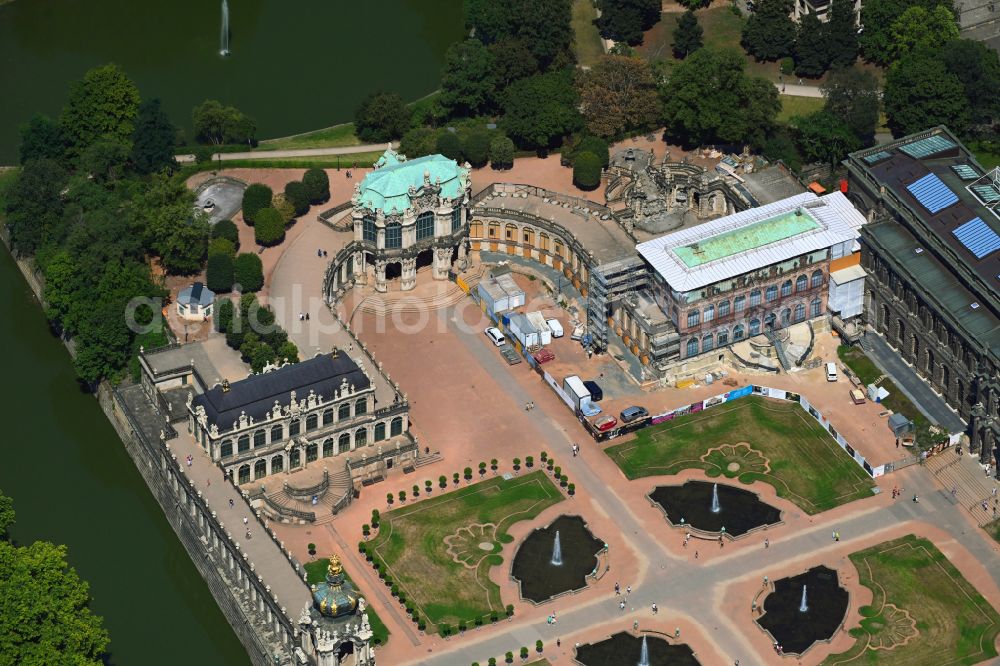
[0,246,248,665]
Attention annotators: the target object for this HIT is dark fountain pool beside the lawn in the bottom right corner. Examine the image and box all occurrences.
[757,566,848,654]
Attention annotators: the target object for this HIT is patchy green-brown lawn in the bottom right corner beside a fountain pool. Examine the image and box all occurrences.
[823,534,1000,666]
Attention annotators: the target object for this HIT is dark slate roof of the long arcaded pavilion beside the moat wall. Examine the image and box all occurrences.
[191,352,371,430]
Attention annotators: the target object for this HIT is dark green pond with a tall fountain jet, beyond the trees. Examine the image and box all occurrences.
[0,0,464,164]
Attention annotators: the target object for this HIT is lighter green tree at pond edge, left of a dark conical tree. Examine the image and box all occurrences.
[59,65,139,158]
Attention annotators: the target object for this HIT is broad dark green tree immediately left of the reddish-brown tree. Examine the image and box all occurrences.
[502,72,582,150]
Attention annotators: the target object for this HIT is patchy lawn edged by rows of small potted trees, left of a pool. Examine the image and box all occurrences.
[367,471,563,630]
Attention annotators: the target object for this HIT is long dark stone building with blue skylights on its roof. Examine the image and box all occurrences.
[846,127,1000,462]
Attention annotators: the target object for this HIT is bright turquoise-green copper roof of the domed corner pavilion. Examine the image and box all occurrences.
[358,149,469,214]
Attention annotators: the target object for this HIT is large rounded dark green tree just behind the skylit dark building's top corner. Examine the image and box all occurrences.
[883,54,969,137]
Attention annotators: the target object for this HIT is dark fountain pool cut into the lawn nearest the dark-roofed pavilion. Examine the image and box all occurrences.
[511,516,604,603]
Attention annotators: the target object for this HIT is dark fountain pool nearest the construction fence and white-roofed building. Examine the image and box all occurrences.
[649,481,781,537]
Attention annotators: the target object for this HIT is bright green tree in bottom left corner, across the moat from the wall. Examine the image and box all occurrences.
[0,493,109,666]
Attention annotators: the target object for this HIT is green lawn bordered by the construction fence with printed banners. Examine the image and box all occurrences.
[605,395,874,514]
